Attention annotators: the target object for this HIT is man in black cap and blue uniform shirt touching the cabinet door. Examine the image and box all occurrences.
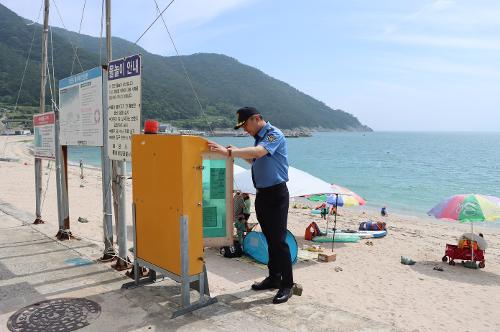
[209,107,293,304]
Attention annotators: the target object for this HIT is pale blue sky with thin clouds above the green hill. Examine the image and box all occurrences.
[0,0,500,131]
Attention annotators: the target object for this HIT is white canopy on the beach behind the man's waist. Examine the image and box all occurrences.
[234,167,335,197]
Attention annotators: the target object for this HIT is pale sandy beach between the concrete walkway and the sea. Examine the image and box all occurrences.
[0,136,500,331]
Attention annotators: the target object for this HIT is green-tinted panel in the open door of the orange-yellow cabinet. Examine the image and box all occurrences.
[202,159,227,237]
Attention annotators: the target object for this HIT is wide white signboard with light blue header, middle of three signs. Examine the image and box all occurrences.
[59,67,103,146]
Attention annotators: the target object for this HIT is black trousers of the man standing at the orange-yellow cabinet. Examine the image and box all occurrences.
[255,183,293,288]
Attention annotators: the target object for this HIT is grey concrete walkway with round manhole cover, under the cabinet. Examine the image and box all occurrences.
[0,202,394,332]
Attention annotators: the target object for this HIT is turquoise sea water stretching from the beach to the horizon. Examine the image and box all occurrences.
[69,132,500,216]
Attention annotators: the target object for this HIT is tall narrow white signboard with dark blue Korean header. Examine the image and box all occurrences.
[108,55,141,161]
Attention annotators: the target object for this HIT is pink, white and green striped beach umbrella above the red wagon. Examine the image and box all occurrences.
[427,194,500,260]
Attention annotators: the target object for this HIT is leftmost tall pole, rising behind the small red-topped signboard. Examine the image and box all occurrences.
[34,0,49,224]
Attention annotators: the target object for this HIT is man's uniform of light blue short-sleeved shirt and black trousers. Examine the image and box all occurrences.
[252,122,293,288]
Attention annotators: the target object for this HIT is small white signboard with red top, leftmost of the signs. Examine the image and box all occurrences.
[33,112,56,159]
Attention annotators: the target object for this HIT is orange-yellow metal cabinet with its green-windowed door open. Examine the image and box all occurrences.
[132,135,233,276]
